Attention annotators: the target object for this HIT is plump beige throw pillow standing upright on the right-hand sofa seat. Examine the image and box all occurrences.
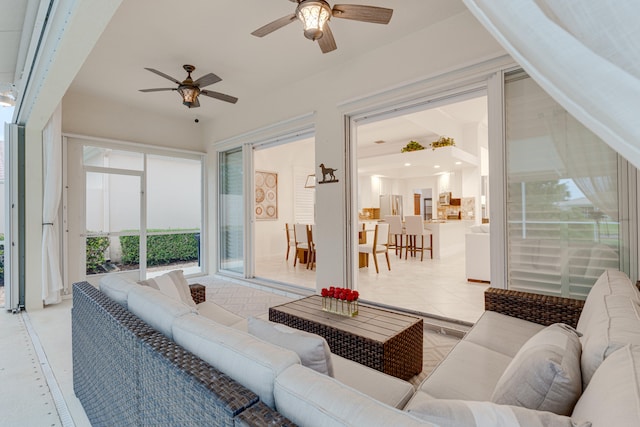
[491,323,582,415]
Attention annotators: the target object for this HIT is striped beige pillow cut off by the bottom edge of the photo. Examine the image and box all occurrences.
[405,399,591,427]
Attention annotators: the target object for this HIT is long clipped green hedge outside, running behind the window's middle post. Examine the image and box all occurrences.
[120,230,199,266]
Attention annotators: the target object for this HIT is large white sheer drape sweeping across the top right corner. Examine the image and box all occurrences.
[463,0,640,168]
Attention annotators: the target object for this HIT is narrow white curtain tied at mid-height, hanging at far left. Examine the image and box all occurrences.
[42,105,63,305]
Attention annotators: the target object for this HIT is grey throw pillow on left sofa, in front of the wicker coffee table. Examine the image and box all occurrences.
[249,317,333,377]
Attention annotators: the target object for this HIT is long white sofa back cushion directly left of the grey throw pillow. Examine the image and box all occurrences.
[173,315,300,408]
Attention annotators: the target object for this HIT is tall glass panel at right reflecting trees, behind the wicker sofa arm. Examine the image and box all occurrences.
[504,71,621,297]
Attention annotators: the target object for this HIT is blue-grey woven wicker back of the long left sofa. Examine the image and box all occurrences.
[71,282,294,426]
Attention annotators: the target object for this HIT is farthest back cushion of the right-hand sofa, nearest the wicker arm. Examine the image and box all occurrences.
[576,269,640,334]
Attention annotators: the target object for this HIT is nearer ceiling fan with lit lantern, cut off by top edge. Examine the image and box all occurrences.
[251,0,393,53]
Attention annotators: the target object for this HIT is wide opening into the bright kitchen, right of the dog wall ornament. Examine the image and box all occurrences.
[355,90,489,321]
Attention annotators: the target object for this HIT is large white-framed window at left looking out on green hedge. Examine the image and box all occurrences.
[77,141,203,278]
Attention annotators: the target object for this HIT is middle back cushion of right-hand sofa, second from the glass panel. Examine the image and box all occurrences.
[581,295,640,387]
